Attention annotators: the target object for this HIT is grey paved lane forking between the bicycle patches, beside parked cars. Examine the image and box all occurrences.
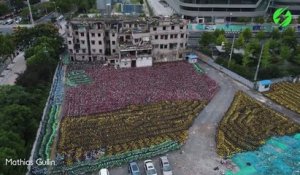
[110,55,300,175]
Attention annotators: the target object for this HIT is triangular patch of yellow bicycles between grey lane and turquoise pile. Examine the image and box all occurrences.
[217,91,300,157]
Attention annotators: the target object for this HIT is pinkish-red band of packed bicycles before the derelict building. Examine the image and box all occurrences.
[63,62,218,116]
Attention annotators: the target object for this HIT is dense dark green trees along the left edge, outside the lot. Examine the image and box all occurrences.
[0,24,63,175]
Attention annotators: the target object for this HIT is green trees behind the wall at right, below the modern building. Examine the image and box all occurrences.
[199,28,300,80]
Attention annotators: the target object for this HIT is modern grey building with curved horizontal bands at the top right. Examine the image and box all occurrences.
[165,0,300,17]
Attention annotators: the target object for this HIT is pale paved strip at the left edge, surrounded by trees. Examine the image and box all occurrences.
[0,52,26,85]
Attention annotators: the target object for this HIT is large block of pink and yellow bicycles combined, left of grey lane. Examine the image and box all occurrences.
[54,61,219,172]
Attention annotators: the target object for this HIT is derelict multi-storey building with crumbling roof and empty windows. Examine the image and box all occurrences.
[67,16,188,67]
